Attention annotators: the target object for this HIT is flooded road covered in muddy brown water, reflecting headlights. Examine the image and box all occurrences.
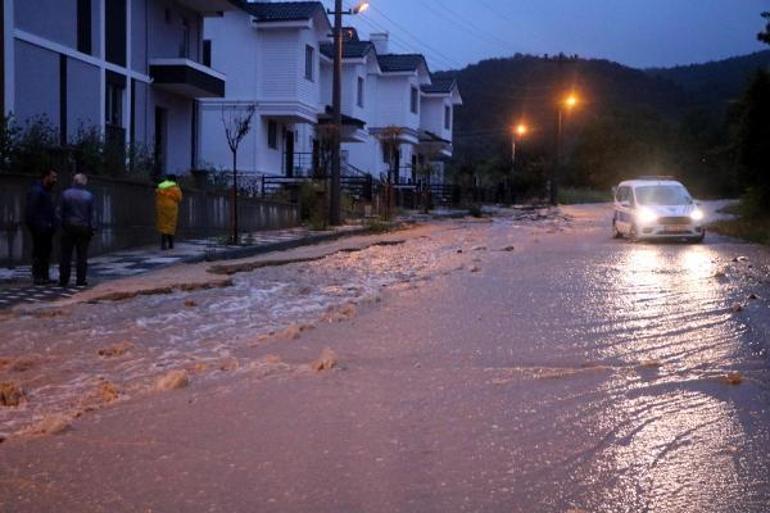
[0,207,770,513]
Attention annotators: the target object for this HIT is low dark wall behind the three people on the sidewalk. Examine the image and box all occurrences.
[0,174,299,265]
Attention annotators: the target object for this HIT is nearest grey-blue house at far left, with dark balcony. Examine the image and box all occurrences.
[0,0,234,173]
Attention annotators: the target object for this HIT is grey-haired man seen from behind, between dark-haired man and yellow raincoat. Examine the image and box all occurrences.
[59,173,94,287]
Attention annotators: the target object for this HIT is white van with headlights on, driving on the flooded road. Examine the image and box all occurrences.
[612,177,706,242]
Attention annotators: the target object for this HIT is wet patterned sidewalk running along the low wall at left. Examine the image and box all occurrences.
[0,225,366,310]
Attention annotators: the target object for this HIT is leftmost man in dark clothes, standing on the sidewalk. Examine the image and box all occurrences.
[25,169,57,285]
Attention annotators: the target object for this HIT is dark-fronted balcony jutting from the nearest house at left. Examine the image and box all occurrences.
[150,59,225,98]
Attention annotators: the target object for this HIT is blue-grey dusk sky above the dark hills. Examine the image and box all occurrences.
[344,0,770,70]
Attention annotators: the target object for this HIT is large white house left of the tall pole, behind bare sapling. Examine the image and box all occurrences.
[199,2,332,176]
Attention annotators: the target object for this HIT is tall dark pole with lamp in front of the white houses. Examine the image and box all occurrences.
[327,0,369,226]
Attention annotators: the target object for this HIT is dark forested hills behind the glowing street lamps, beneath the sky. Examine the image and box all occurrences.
[440,51,770,161]
